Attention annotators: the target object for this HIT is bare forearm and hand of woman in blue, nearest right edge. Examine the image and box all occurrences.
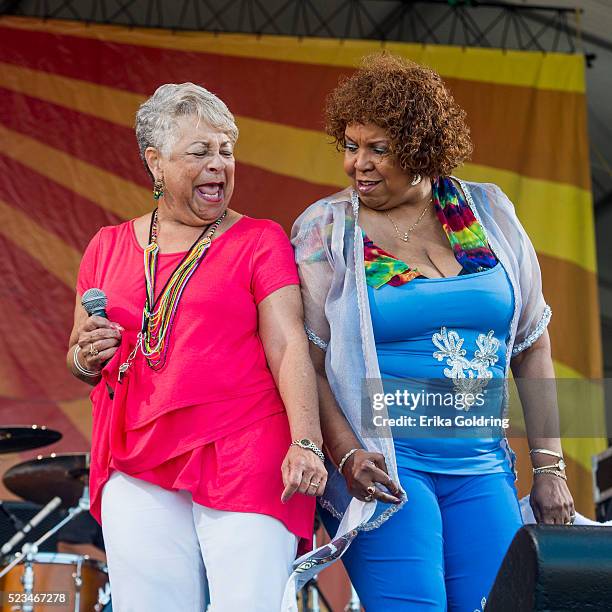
[510,331,574,524]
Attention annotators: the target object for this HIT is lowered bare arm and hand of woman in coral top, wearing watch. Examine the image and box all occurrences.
[258,285,327,501]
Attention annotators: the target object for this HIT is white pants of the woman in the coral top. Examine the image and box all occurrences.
[102,472,297,612]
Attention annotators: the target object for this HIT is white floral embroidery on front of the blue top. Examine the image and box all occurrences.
[431,327,499,412]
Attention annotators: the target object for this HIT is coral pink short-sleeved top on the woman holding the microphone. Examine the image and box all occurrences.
[77,216,314,538]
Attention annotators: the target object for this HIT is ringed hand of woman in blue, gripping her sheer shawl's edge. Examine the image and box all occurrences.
[342,449,402,504]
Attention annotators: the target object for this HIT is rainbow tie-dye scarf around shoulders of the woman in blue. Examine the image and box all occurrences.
[364,177,497,289]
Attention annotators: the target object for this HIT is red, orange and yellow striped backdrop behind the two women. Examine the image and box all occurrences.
[0,18,605,536]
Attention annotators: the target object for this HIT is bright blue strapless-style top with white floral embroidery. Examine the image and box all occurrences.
[368,263,514,474]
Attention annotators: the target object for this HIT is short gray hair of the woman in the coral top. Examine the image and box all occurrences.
[135,83,238,178]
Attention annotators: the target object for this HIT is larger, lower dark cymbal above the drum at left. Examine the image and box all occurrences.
[2,453,89,508]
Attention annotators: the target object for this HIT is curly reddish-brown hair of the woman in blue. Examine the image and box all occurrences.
[325,53,472,177]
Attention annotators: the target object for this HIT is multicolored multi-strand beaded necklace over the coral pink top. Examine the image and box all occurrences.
[119,208,227,382]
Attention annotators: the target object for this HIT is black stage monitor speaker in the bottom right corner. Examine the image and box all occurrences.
[486,525,612,612]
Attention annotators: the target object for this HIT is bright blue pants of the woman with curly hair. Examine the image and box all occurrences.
[320,468,522,612]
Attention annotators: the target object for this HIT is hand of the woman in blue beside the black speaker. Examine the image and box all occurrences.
[529,474,576,525]
